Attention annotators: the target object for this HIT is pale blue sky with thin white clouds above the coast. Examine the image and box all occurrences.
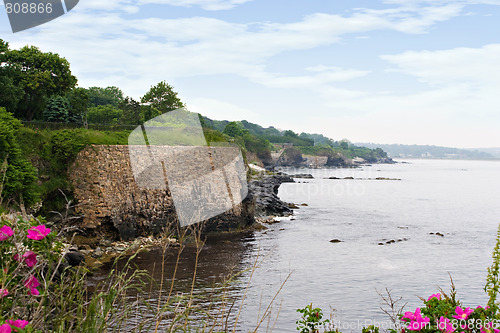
[0,0,500,148]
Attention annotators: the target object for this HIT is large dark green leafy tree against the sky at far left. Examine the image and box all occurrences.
[1,41,77,120]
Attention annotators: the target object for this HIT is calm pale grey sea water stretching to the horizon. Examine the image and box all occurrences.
[90,160,500,332]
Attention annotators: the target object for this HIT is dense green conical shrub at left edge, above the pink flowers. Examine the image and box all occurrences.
[0,107,39,204]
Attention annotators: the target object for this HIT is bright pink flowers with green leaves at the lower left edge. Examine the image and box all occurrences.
[0,219,51,333]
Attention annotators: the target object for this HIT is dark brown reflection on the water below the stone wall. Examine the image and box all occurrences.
[88,232,255,332]
